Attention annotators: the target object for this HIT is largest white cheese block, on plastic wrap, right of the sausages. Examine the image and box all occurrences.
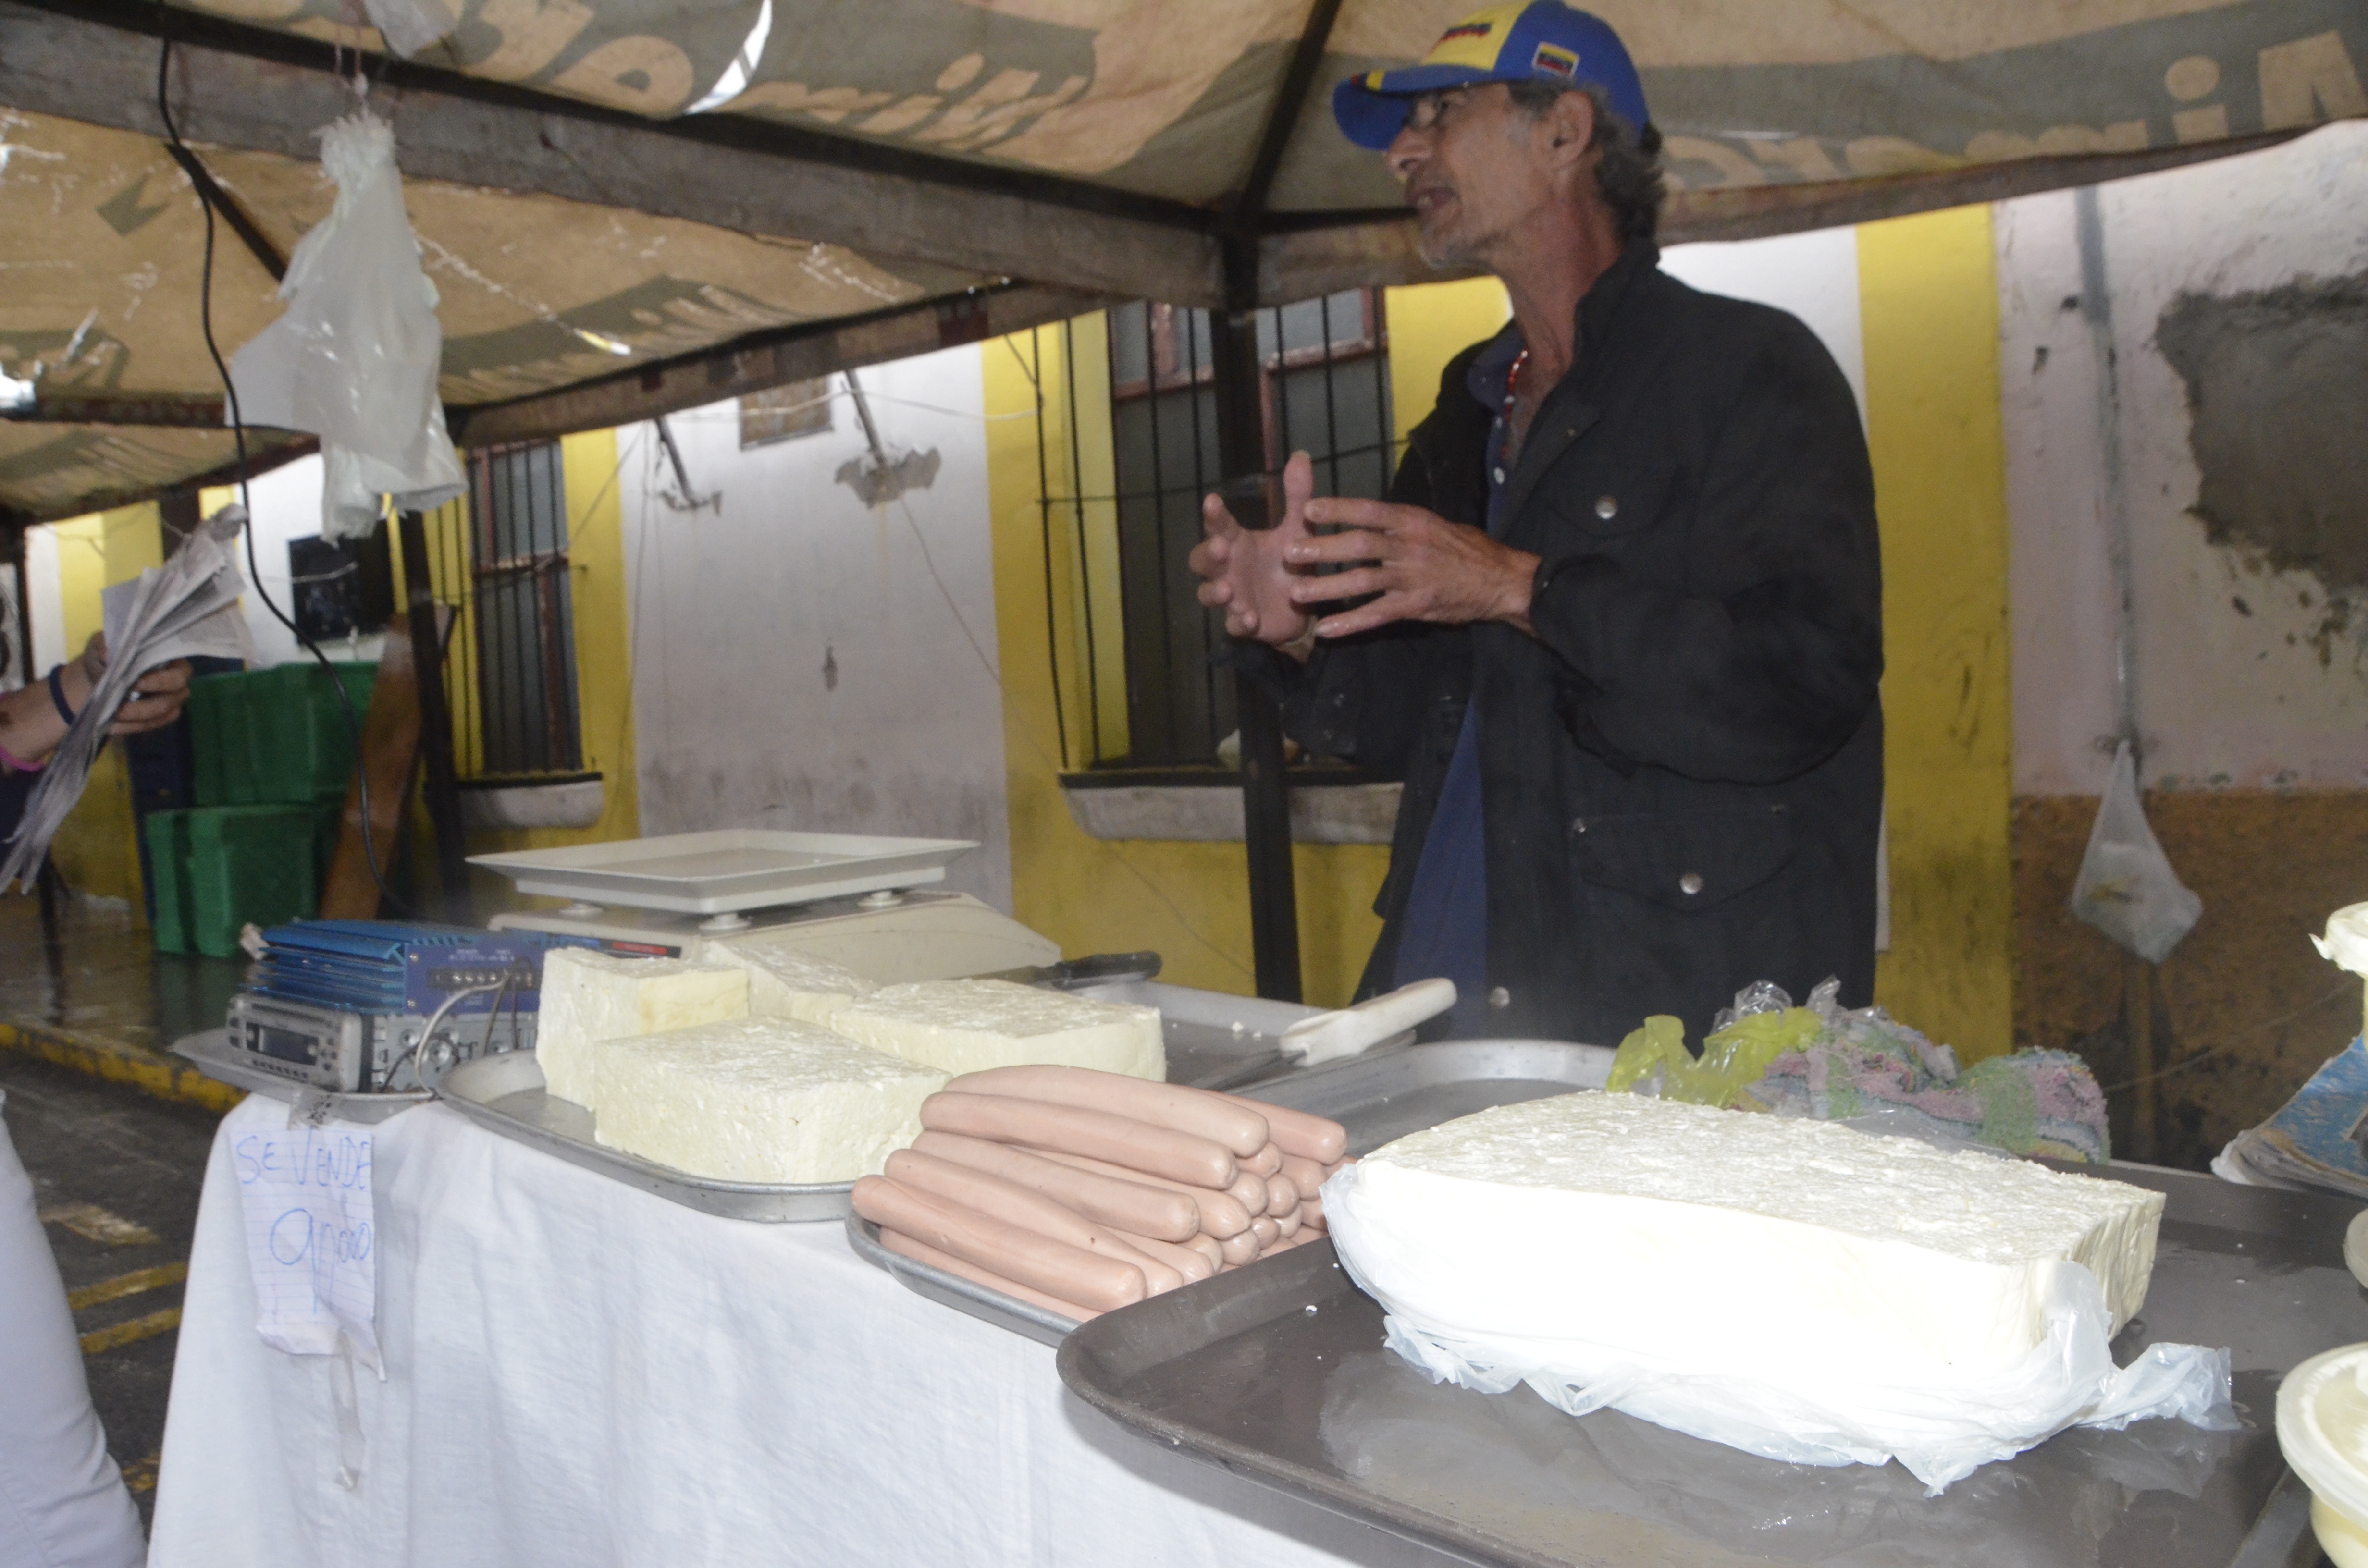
[1324,1094,2162,1385]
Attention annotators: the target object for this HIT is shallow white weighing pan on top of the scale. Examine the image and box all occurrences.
[469,827,978,914]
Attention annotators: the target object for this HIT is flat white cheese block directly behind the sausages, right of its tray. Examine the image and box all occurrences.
[826,980,1168,1082]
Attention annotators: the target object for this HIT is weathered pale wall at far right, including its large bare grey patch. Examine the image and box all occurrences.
[1996,121,2368,794]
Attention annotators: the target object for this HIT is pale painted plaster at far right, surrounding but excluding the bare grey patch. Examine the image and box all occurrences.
[1996,121,2368,794]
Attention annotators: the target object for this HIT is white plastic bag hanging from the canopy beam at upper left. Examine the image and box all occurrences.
[230,109,467,540]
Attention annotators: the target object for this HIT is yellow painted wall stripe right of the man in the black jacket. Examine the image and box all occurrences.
[1859,206,2015,1061]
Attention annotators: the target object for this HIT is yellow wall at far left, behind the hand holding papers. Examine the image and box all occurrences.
[49,504,163,924]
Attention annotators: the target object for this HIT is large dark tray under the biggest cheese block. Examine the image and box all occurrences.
[1059,1165,2368,1568]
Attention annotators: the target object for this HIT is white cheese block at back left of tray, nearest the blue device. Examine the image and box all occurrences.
[535,947,748,1106]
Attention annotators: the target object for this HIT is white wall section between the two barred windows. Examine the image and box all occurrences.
[618,346,1011,909]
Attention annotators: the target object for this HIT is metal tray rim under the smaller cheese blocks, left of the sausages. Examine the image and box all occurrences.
[436,1052,855,1222]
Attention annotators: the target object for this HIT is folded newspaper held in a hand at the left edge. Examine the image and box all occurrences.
[0,504,256,891]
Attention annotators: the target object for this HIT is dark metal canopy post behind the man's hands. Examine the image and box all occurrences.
[1210,242,1300,1002]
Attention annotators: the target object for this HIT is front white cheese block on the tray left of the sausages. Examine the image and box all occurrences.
[592,1018,945,1182]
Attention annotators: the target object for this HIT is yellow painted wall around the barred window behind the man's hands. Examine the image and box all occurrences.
[985,280,1506,1004]
